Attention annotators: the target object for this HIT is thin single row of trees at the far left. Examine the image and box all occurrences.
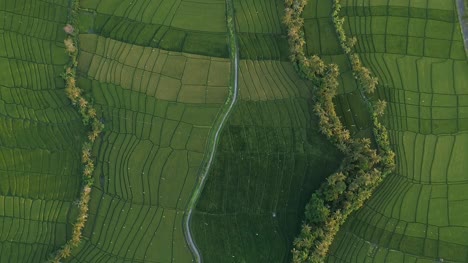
[50,0,104,263]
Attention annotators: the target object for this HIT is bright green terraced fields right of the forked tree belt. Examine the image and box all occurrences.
[329,1,468,262]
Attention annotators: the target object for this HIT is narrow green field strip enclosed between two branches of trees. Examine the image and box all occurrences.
[303,0,371,137]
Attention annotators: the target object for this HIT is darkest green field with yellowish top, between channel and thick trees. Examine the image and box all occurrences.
[192,60,338,262]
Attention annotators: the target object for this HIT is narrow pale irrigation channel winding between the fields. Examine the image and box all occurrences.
[184,0,239,263]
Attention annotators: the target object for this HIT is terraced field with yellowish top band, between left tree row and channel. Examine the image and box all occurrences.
[65,34,230,262]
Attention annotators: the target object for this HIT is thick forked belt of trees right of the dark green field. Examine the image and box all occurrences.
[283,0,395,263]
